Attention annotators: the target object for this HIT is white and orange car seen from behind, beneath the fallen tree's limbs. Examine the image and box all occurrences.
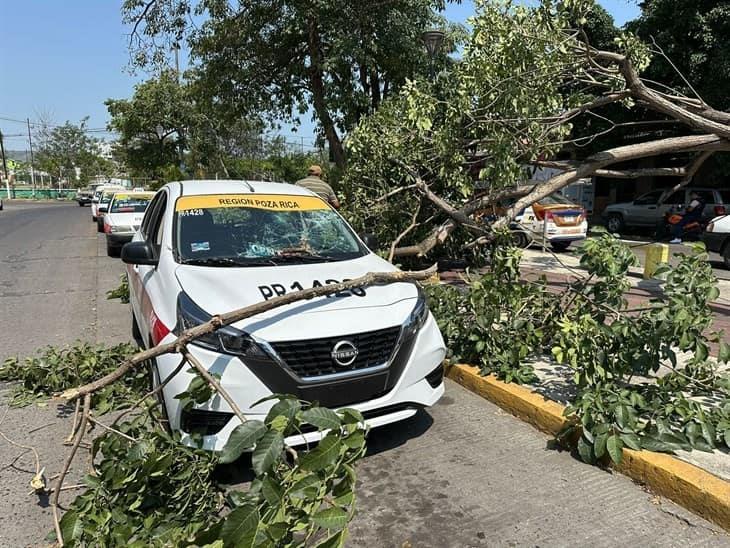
[511,194,588,251]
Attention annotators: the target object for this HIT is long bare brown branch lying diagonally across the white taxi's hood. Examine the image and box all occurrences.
[61,265,436,401]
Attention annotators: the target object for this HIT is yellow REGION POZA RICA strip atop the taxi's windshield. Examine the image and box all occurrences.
[175,194,329,211]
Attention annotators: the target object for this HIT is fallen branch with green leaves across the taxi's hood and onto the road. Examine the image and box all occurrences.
[3,267,435,547]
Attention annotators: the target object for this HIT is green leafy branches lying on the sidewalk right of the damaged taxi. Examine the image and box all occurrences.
[430,235,730,462]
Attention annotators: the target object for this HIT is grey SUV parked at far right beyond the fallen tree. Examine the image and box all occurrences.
[602,187,730,232]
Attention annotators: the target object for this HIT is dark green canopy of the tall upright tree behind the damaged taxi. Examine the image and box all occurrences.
[123,0,459,167]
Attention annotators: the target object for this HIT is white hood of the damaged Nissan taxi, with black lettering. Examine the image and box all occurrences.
[175,253,418,341]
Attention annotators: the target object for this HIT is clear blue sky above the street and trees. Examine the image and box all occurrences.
[0,0,639,150]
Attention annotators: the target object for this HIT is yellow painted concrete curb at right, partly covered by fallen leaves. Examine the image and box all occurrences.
[446,364,730,531]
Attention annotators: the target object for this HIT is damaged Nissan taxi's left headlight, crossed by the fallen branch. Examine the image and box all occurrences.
[173,291,266,357]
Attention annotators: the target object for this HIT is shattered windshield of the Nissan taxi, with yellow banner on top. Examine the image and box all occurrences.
[175,194,366,266]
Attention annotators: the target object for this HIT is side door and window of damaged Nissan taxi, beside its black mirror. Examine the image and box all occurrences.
[130,190,168,344]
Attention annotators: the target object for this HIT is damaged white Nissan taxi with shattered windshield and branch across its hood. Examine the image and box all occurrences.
[122,181,446,450]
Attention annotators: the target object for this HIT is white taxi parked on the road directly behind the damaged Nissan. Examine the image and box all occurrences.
[104,192,155,257]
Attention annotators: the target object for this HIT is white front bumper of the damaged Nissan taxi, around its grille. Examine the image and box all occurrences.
[157,315,446,451]
